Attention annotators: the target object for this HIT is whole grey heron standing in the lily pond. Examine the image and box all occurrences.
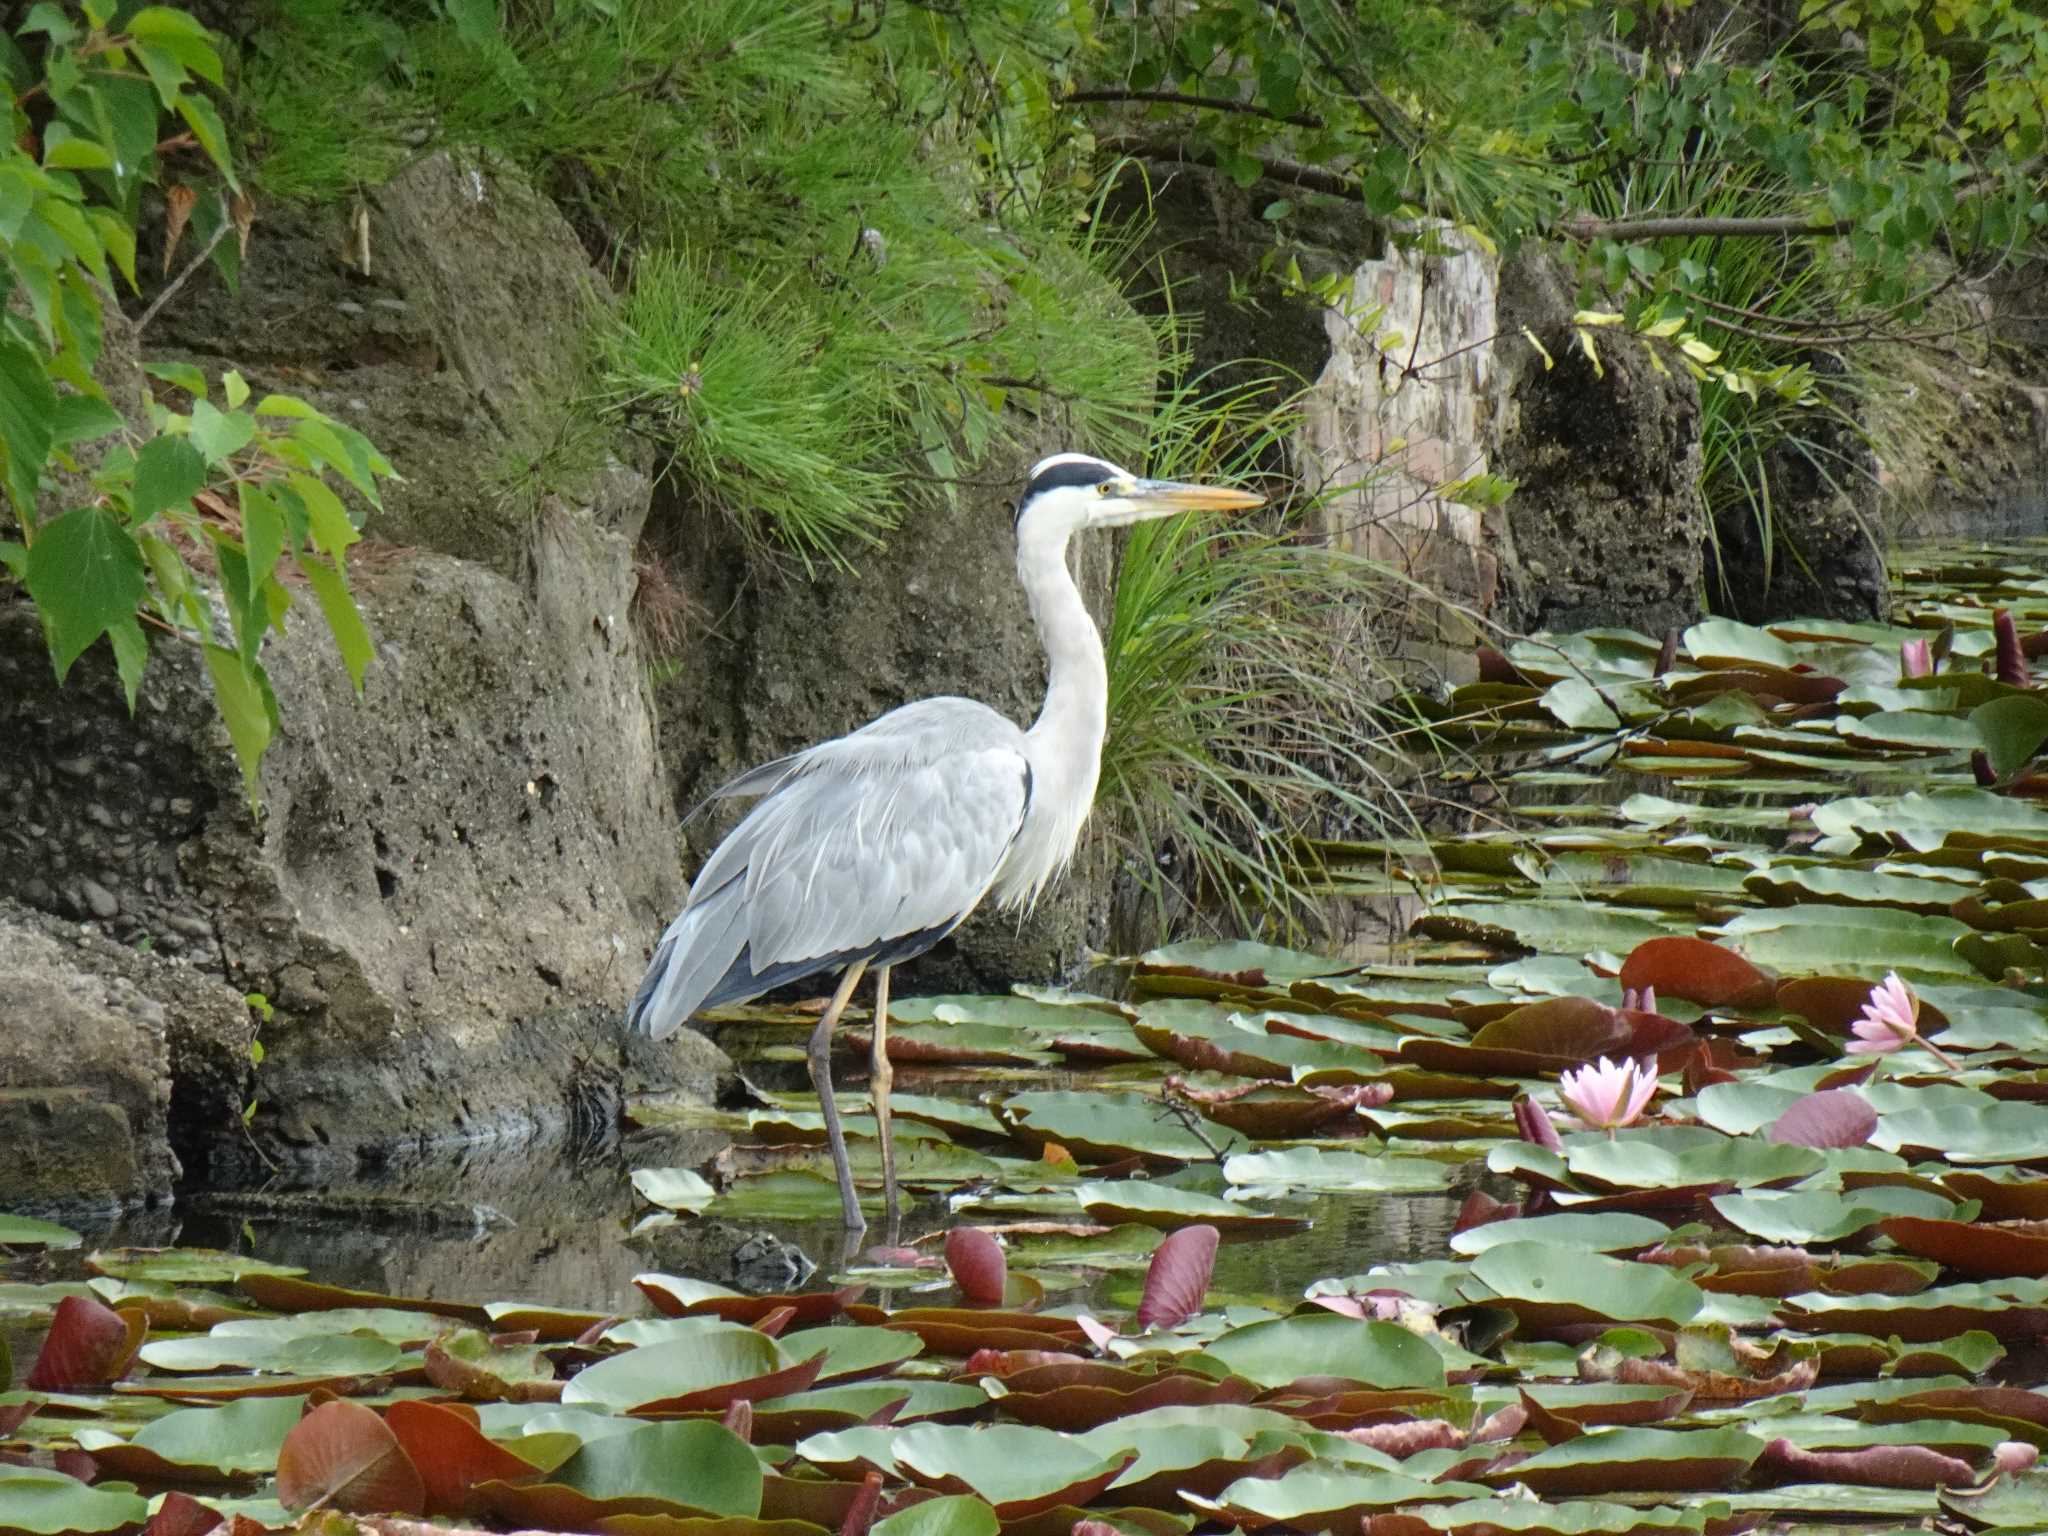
[627,453,1264,1231]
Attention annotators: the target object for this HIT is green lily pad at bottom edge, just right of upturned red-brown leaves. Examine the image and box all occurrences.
[475,1419,762,1530]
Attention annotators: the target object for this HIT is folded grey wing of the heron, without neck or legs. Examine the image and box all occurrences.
[629,698,1030,1038]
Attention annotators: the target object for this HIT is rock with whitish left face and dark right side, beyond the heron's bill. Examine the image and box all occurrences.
[1294,229,1706,651]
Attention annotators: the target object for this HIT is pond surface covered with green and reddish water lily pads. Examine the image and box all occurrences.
[19,541,2048,1536]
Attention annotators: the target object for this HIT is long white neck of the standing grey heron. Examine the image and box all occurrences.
[995,520,1110,905]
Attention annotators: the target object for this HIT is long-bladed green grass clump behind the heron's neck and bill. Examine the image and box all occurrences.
[1102,379,1401,938]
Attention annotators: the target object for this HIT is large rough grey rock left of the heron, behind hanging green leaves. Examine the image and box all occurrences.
[0,156,725,1200]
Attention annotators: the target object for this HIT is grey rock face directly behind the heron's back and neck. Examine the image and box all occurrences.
[635,434,1114,993]
